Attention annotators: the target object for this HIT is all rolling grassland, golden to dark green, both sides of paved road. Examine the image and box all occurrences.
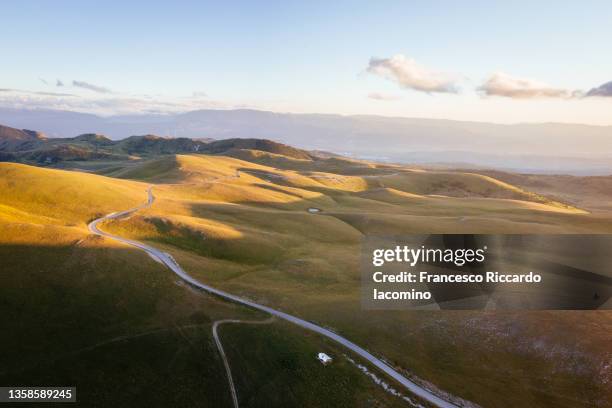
[0,149,612,408]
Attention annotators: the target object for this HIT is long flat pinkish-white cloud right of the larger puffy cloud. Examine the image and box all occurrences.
[478,72,581,99]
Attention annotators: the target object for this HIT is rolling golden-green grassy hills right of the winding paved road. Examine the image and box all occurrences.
[98,150,612,407]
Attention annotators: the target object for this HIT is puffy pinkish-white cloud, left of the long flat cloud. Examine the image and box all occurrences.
[367,54,457,93]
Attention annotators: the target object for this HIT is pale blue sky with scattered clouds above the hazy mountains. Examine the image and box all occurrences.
[0,1,612,124]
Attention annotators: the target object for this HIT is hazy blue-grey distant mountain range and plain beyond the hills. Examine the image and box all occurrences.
[0,108,612,174]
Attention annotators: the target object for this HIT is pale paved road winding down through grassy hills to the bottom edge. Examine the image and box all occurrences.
[87,187,458,408]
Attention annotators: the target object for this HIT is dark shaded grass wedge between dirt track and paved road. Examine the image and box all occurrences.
[221,322,416,408]
